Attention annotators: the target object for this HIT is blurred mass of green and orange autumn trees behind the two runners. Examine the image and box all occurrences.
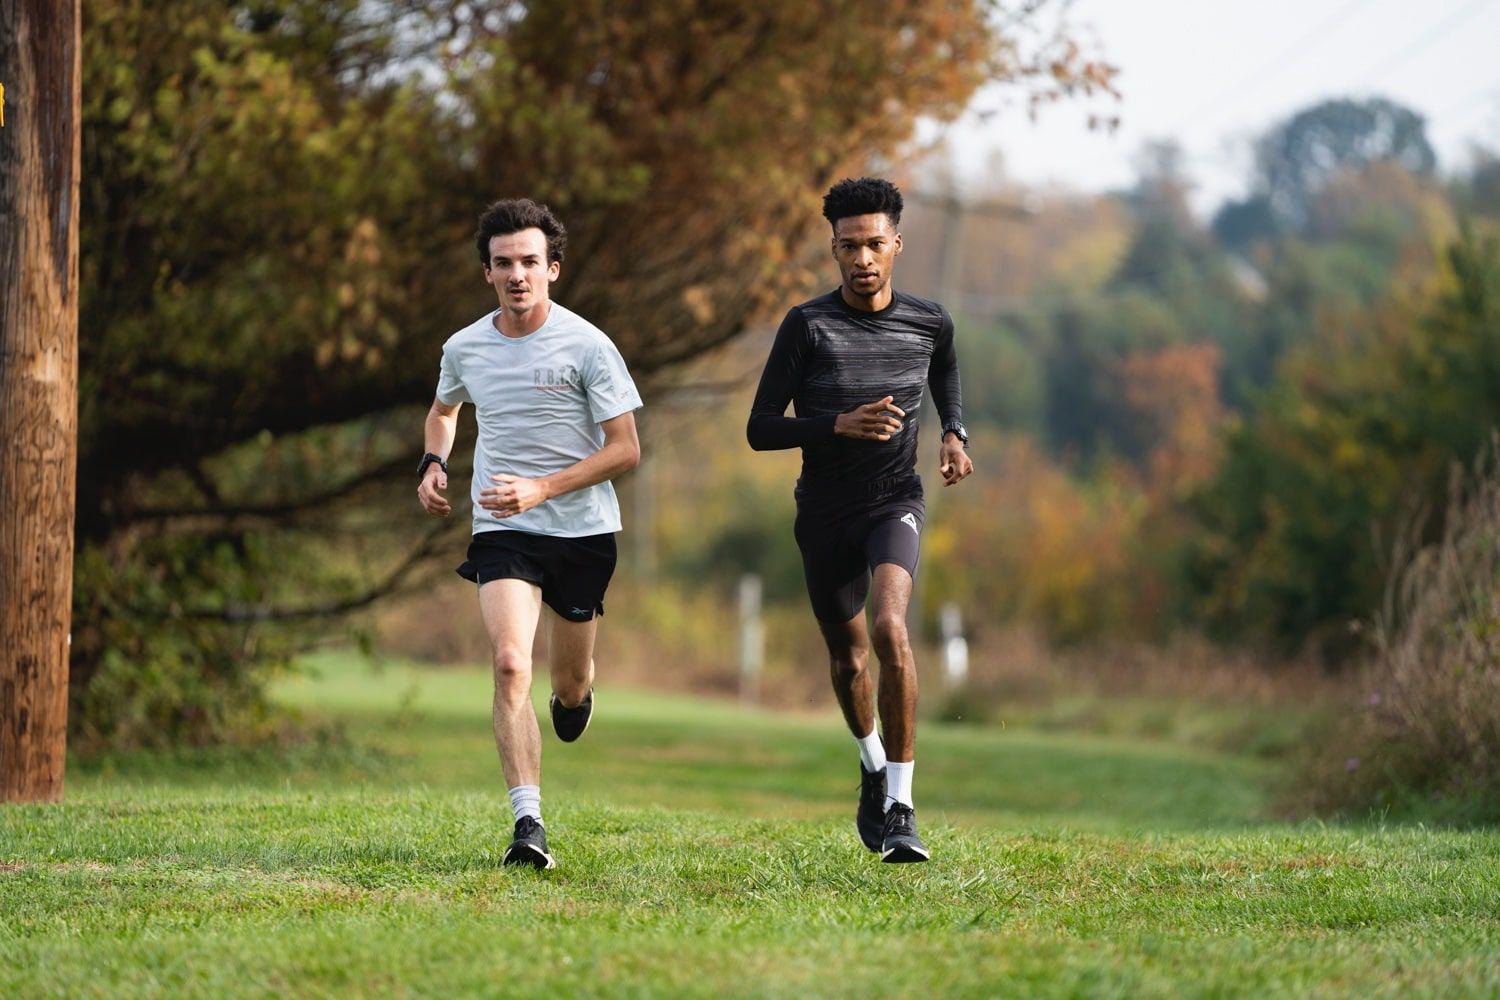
[72,0,1500,821]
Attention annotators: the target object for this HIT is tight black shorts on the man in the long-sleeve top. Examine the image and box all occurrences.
[795,474,927,622]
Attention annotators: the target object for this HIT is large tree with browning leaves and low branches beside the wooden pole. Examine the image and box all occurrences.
[74,0,1109,739]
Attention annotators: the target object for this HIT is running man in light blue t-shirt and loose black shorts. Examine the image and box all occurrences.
[417,198,641,868]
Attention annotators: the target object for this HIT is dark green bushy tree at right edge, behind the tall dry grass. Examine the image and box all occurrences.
[1185,234,1500,660]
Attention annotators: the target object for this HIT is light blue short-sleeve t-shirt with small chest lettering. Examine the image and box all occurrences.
[438,303,642,538]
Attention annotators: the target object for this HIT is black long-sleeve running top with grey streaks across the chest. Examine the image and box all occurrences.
[746,289,963,483]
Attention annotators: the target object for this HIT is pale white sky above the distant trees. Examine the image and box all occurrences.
[929,0,1500,214]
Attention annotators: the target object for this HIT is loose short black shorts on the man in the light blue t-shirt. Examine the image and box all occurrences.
[458,529,617,622]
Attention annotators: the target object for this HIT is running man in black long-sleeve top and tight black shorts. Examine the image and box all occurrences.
[746,177,974,862]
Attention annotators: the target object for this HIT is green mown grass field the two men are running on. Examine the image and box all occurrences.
[0,655,1500,997]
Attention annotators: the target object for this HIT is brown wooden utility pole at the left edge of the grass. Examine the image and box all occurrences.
[0,0,80,802]
